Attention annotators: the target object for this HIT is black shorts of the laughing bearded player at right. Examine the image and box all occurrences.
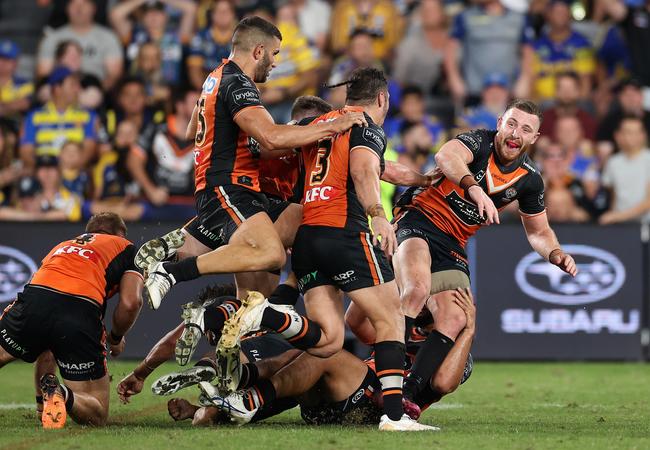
[395,208,469,277]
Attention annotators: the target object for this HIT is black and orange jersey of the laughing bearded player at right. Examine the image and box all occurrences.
[398,130,545,246]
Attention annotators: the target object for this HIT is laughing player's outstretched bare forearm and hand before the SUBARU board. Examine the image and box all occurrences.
[521,212,578,277]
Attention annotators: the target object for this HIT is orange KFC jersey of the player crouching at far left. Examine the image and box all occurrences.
[29,233,139,306]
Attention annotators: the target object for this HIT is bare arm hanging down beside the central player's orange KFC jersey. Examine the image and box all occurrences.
[350,147,397,257]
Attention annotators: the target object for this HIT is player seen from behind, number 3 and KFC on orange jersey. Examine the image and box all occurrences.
[217,68,429,430]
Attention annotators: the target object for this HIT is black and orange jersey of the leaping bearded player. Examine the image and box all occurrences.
[194,59,263,192]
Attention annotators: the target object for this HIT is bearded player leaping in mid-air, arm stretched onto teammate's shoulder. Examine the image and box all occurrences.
[136,17,367,309]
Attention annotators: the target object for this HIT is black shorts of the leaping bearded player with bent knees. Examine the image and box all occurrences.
[185,185,269,250]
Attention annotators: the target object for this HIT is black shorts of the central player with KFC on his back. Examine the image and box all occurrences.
[291,225,395,293]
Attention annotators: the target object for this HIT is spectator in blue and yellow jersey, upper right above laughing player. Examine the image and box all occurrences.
[531,0,596,102]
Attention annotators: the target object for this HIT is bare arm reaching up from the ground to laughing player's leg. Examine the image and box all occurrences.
[431,288,476,394]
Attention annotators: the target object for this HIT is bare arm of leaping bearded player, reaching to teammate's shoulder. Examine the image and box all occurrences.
[234,108,368,150]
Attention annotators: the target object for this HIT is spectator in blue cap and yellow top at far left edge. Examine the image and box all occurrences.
[0,40,34,123]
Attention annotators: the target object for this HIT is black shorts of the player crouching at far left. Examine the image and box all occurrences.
[0,285,106,381]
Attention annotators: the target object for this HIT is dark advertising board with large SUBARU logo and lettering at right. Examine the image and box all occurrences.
[472,225,644,360]
